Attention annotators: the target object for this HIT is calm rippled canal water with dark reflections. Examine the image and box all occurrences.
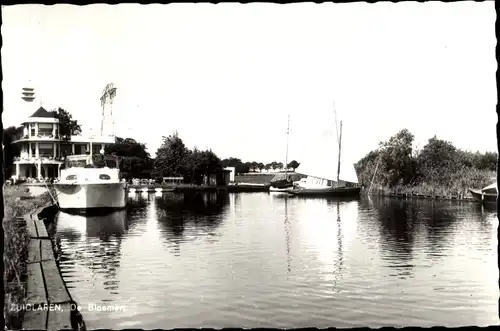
[53,193,499,329]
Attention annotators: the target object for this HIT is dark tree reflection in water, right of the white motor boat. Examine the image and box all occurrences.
[156,192,229,240]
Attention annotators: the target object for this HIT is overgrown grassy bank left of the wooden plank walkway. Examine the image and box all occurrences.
[3,186,51,330]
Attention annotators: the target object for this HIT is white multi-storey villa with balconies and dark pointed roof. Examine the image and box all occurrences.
[13,107,115,180]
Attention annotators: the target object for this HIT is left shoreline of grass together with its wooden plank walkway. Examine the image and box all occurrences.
[4,186,85,331]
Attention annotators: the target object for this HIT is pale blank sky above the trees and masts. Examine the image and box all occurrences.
[1,1,497,163]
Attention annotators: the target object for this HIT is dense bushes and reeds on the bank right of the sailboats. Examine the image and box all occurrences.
[355,129,498,197]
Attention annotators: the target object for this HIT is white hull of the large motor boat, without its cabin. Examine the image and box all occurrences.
[54,182,127,213]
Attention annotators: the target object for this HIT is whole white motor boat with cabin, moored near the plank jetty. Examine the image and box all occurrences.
[54,155,127,213]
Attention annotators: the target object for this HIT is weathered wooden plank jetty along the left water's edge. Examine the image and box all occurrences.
[22,204,83,330]
